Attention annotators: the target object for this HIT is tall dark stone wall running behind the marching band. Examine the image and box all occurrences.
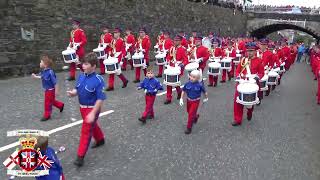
[0,0,247,77]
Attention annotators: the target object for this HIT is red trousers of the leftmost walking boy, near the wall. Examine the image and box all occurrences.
[43,89,63,118]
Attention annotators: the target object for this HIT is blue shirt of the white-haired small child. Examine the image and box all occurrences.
[182,81,206,100]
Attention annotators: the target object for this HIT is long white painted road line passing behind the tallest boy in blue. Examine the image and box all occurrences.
[0,110,114,152]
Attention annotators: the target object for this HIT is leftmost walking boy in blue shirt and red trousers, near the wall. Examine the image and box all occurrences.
[32,55,64,121]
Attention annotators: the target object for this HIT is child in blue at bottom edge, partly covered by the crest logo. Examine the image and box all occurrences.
[35,136,65,180]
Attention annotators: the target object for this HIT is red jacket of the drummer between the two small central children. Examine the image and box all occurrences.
[167,45,188,67]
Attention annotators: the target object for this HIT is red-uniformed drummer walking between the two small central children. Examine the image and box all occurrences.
[164,35,188,104]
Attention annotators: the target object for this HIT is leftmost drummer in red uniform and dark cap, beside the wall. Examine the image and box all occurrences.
[67,20,87,81]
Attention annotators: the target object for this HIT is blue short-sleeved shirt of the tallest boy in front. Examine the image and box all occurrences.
[76,72,106,106]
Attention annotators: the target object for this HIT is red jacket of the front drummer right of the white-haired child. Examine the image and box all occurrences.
[236,57,264,79]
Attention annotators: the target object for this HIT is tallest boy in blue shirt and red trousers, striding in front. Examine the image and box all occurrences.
[67,53,106,167]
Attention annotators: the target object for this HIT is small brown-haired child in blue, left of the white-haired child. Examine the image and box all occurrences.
[138,66,163,124]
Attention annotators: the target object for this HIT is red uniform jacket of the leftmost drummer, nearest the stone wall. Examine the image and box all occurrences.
[70,28,87,58]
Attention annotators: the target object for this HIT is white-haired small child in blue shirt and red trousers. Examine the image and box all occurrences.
[180,70,208,134]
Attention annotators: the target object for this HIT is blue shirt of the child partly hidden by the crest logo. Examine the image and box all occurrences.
[36,147,62,180]
